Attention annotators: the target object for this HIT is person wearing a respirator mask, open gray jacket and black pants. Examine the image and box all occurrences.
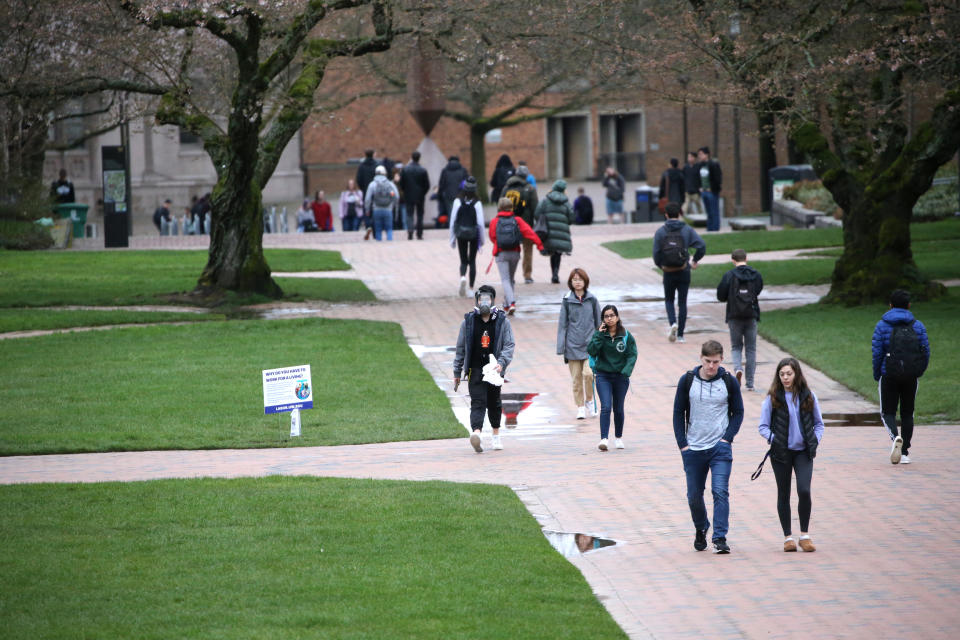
[453,284,514,453]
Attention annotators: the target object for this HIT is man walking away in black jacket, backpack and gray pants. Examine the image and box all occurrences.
[717,249,763,391]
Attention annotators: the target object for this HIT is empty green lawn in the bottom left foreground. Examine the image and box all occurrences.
[0,477,626,640]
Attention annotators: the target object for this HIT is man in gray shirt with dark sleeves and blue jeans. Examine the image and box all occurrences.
[673,340,743,553]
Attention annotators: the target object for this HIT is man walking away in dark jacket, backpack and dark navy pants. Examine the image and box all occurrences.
[653,202,707,342]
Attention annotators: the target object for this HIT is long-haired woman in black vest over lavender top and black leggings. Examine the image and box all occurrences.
[758,358,823,551]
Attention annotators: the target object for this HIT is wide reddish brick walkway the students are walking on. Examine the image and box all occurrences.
[0,225,960,638]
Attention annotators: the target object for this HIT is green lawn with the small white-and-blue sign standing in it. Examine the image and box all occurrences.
[0,318,466,455]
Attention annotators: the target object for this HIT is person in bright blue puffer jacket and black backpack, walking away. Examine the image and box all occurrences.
[873,289,930,464]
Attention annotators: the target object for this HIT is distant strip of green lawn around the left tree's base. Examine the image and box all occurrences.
[0,249,374,307]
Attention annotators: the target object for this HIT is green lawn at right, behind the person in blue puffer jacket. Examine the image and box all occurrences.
[757,287,960,423]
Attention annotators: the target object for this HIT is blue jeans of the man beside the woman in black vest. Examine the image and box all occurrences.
[680,442,733,540]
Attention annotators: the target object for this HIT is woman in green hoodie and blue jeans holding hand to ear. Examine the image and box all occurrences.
[587,304,637,451]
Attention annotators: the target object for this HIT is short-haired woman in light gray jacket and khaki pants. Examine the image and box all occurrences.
[557,268,600,420]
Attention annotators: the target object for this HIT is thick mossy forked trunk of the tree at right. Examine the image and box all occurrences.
[791,91,960,305]
